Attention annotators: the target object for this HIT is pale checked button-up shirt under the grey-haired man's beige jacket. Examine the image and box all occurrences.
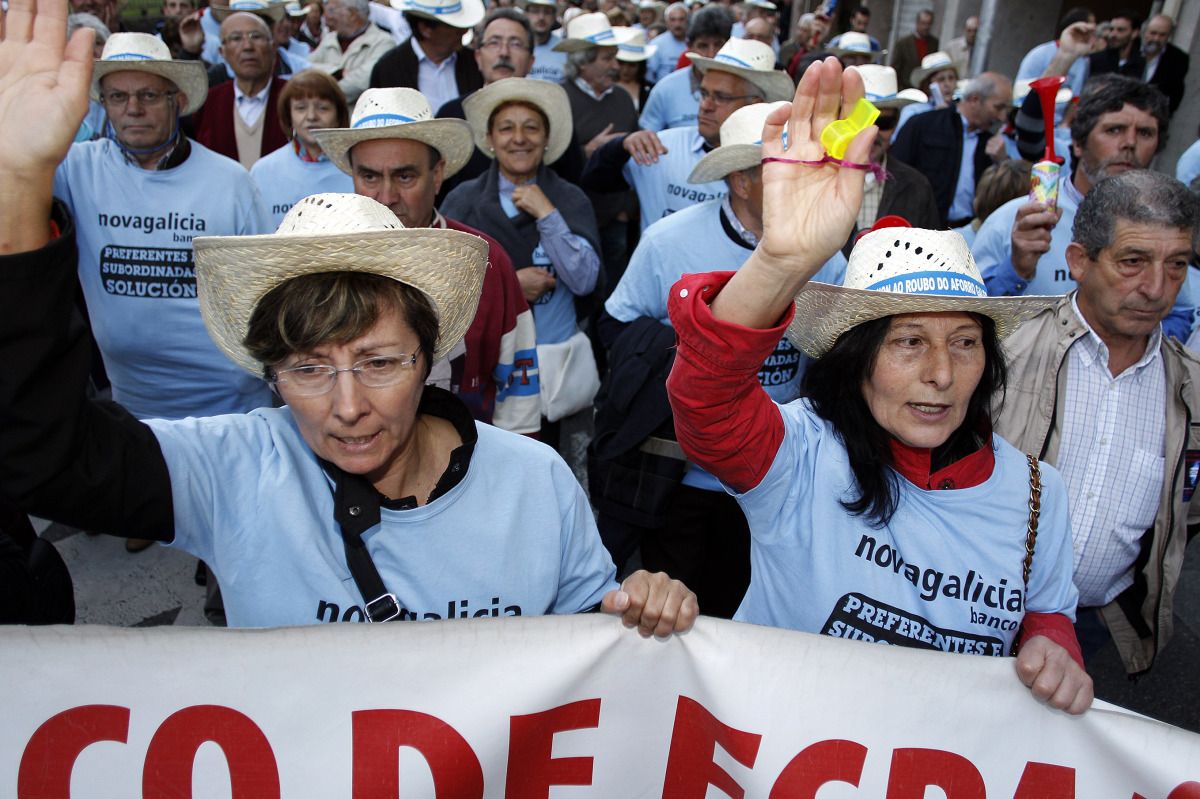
[1060,296,1166,607]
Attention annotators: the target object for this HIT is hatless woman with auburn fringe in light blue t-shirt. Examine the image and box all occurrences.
[250,70,354,224]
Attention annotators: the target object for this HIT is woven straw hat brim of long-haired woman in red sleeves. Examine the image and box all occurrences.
[786,283,1062,358]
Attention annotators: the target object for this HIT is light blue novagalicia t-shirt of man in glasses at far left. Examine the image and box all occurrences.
[54,139,274,419]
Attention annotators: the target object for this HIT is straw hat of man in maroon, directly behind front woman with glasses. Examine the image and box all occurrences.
[312,89,475,178]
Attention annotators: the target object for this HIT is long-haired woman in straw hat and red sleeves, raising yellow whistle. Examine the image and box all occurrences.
[667,59,1092,713]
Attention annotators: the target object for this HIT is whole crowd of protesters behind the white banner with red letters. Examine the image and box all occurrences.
[0,0,1200,713]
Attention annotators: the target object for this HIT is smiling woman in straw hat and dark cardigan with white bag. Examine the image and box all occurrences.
[442,78,600,444]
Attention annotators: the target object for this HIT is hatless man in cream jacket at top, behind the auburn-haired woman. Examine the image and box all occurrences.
[308,0,394,106]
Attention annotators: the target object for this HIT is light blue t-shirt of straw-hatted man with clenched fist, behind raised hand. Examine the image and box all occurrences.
[622,125,728,230]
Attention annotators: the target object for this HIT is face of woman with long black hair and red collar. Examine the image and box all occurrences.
[863,312,986,449]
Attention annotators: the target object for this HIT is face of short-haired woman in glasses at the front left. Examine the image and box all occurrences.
[278,308,428,499]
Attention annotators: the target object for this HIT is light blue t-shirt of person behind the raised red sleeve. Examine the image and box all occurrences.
[604,199,846,491]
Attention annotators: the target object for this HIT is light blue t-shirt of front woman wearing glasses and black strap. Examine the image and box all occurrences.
[150,408,617,627]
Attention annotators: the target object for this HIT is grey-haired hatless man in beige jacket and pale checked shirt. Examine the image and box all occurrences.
[996,169,1200,674]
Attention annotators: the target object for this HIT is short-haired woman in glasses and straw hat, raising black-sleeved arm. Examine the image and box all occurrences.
[0,0,697,635]
